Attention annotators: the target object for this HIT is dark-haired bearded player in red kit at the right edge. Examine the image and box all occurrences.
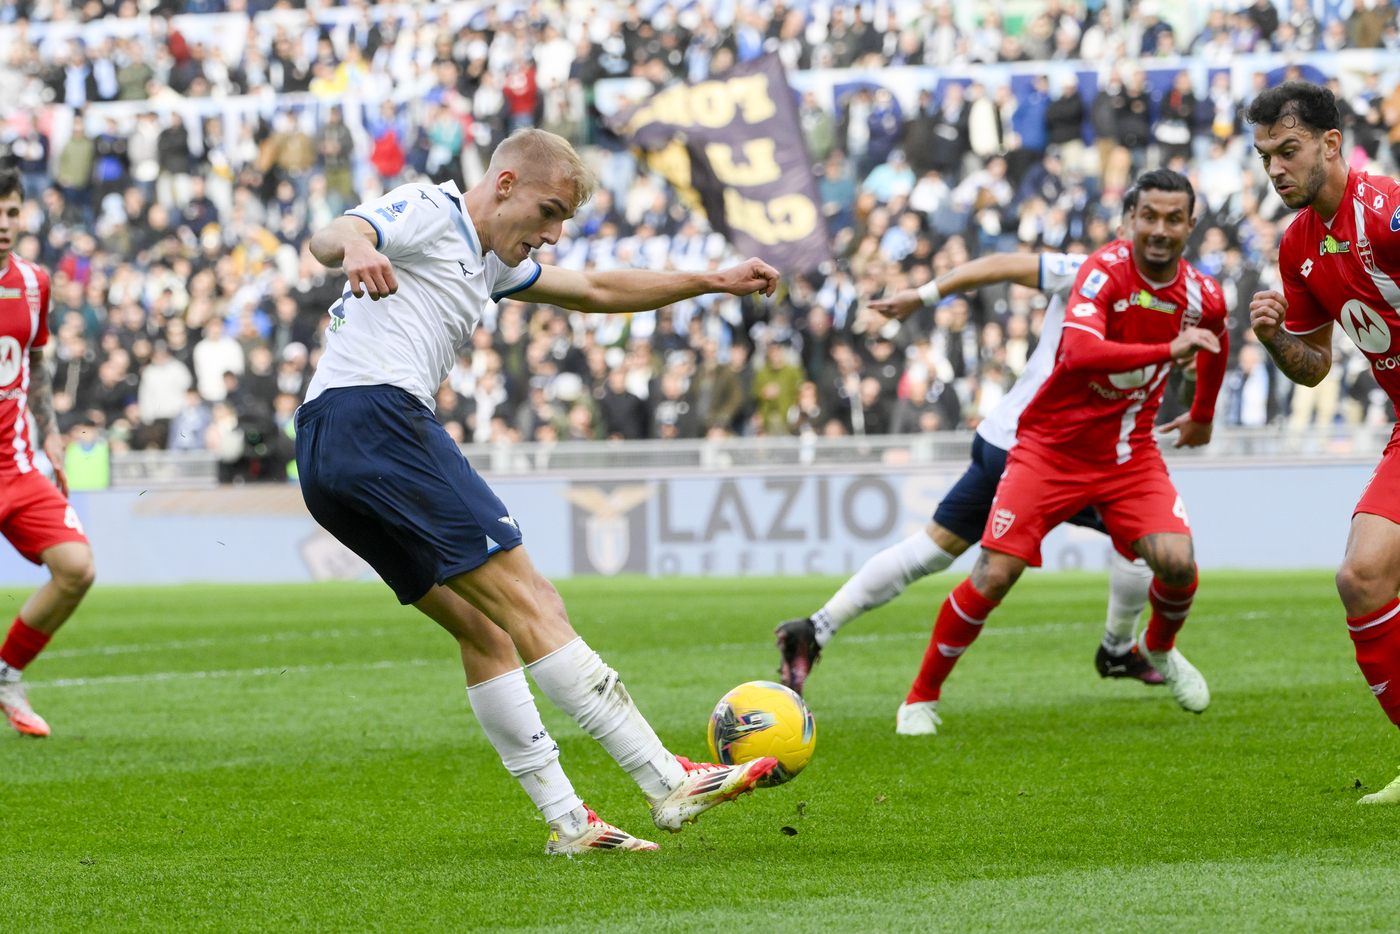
[1249,81,1400,804]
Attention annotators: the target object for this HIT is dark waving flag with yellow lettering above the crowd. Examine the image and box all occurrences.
[612,52,832,273]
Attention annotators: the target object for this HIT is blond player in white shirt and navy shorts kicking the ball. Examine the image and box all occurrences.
[305,129,778,854]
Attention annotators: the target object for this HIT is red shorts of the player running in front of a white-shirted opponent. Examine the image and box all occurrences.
[981,441,1191,567]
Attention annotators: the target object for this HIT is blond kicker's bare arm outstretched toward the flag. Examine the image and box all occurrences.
[511,259,778,314]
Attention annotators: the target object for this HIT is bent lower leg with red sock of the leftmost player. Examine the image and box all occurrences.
[0,542,97,737]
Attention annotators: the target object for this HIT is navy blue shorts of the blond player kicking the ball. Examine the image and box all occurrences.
[297,386,521,604]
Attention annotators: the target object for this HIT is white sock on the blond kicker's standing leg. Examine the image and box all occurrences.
[466,668,588,833]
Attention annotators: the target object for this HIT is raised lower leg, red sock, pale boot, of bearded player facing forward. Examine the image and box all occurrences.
[1133,532,1211,714]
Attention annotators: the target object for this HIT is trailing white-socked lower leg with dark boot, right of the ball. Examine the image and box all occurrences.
[773,522,970,695]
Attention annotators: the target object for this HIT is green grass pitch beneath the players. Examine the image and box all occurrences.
[0,573,1400,934]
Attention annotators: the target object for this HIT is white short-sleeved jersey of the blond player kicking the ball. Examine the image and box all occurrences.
[307,181,539,409]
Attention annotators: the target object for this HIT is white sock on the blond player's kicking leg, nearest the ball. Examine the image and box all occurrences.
[526,637,686,798]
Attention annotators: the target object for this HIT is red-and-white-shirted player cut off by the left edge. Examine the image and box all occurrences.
[0,169,94,737]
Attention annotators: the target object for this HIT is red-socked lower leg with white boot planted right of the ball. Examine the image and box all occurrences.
[895,546,1028,735]
